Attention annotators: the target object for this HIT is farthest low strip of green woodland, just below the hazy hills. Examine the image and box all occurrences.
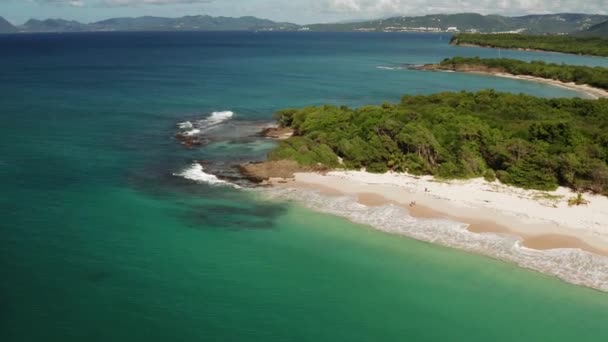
[450,33,608,57]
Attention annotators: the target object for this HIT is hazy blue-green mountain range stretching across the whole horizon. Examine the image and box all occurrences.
[0,13,608,35]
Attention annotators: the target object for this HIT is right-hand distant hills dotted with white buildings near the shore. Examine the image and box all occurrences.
[307,13,608,34]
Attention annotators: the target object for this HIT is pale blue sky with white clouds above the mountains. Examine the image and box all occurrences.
[0,0,608,24]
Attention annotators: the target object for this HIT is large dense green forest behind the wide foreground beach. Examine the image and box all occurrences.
[269,90,608,195]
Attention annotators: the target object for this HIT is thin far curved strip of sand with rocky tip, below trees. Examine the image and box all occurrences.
[417,64,608,99]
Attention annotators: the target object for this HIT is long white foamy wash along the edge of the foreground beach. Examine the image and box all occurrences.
[265,188,608,292]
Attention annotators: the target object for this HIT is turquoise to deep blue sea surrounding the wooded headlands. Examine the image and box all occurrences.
[0,33,608,342]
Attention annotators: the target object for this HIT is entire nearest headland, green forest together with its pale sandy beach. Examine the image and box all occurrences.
[248,90,608,291]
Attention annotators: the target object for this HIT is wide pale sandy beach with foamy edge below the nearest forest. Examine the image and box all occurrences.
[270,171,608,292]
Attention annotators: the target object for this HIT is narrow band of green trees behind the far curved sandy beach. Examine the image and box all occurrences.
[439,57,608,90]
